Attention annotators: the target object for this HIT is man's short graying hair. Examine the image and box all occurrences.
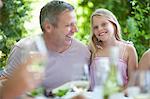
[40,0,74,31]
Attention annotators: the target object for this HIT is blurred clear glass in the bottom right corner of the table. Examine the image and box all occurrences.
[127,70,150,99]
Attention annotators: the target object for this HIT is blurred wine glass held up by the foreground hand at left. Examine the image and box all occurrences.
[22,36,48,97]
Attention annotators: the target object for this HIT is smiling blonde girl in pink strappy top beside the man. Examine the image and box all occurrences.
[90,8,138,88]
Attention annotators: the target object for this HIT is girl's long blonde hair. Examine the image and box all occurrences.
[90,8,122,59]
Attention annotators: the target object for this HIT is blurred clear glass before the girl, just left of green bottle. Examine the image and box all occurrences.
[93,57,110,99]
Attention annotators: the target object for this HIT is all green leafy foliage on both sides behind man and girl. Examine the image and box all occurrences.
[0,0,150,67]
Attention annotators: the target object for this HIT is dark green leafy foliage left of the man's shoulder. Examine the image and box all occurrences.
[0,0,31,67]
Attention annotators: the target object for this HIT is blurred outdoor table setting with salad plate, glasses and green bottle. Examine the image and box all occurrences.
[19,44,150,99]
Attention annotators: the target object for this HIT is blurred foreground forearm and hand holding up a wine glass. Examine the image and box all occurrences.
[0,59,38,99]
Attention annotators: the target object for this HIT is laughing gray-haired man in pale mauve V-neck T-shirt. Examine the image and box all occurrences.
[2,0,90,96]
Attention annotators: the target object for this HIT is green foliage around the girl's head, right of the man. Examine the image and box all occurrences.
[76,0,150,59]
